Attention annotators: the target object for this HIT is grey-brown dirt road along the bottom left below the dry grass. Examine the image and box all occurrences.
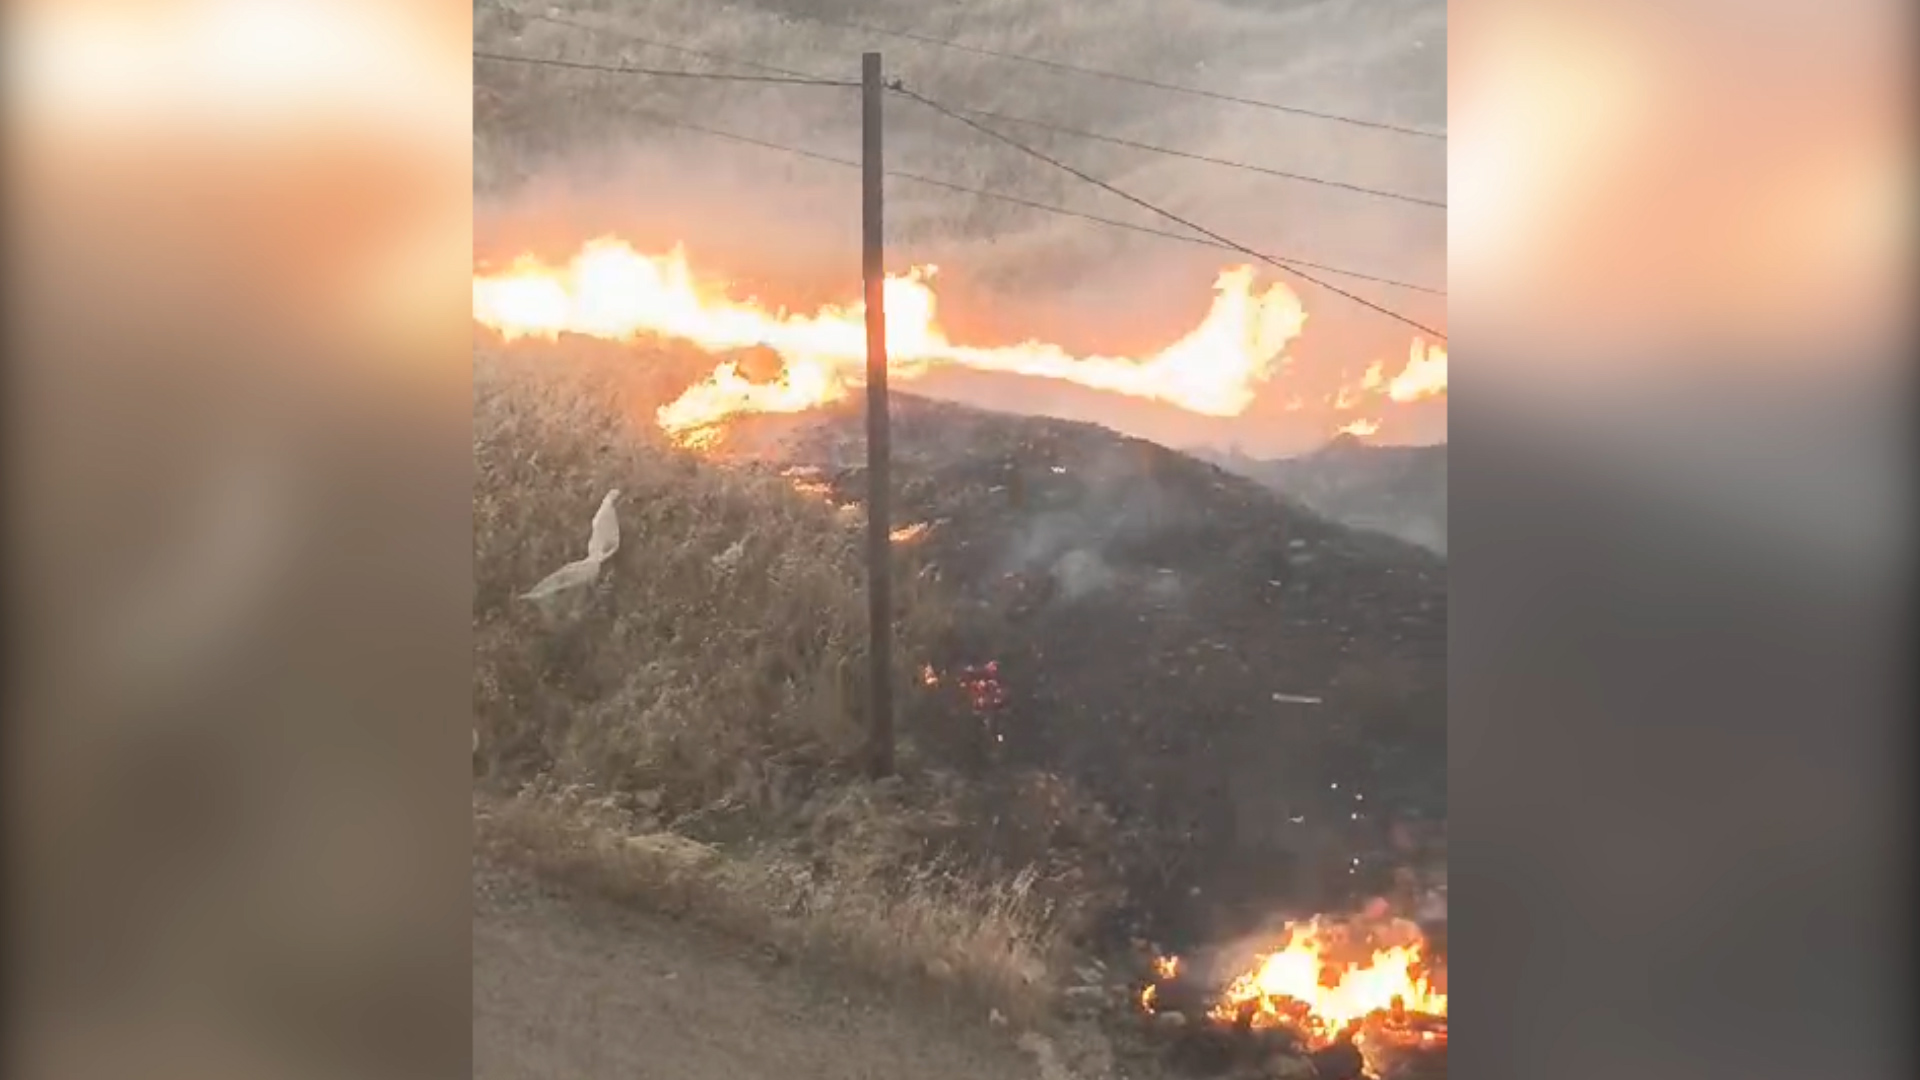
[472,867,1043,1080]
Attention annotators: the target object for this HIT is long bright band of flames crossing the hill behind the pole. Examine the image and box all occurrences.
[472,238,1306,438]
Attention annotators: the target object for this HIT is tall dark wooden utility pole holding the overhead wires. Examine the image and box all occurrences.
[860,52,893,776]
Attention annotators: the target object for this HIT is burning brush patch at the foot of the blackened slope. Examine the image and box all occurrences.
[1137,917,1448,1080]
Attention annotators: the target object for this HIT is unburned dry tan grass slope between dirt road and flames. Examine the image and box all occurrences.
[474,342,1104,1017]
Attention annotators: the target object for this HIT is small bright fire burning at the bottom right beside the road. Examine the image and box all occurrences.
[1139,917,1448,1074]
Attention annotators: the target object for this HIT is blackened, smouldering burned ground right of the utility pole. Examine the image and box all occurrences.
[730,396,1446,944]
